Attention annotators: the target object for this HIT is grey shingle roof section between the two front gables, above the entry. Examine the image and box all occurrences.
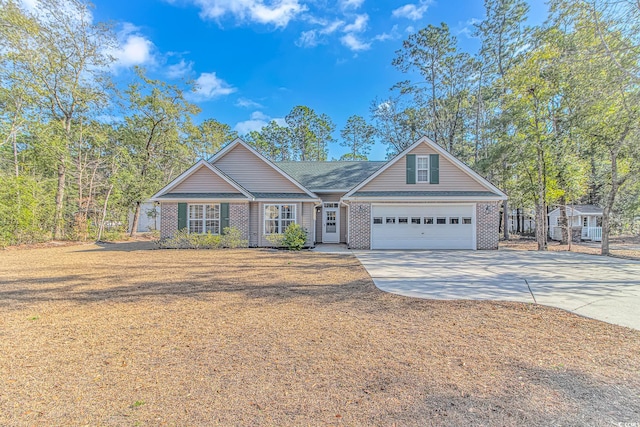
[276,161,387,191]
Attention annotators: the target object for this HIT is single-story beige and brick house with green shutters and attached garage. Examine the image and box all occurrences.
[151,138,507,249]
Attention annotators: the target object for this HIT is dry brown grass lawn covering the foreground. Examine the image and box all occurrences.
[0,242,640,426]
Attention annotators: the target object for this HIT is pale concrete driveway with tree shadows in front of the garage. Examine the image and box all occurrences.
[354,250,640,330]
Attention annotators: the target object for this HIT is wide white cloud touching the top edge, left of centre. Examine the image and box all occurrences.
[191,0,307,27]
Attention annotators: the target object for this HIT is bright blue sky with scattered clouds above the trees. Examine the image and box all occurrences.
[93,0,546,160]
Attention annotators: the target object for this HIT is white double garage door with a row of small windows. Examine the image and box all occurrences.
[371,204,476,249]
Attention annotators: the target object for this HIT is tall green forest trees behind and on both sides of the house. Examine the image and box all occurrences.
[0,0,640,253]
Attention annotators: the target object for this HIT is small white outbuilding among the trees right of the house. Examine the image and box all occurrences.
[549,205,602,242]
